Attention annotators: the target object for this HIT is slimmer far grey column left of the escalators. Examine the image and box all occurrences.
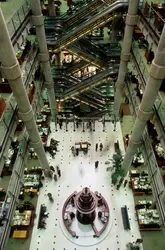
[31,0,57,126]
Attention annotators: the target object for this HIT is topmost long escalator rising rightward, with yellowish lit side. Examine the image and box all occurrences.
[47,0,128,52]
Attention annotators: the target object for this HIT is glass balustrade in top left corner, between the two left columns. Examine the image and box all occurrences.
[6,0,30,37]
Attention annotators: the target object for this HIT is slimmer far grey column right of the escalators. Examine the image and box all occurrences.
[114,0,139,117]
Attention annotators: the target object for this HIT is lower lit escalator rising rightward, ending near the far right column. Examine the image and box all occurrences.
[62,66,118,101]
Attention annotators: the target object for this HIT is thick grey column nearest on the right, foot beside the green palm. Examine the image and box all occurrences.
[122,26,165,175]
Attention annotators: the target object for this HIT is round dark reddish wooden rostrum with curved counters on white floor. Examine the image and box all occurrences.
[62,187,110,238]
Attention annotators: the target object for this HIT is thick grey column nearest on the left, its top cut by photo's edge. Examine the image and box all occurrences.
[0,9,49,173]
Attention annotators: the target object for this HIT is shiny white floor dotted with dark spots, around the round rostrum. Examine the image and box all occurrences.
[30,122,140,250]
